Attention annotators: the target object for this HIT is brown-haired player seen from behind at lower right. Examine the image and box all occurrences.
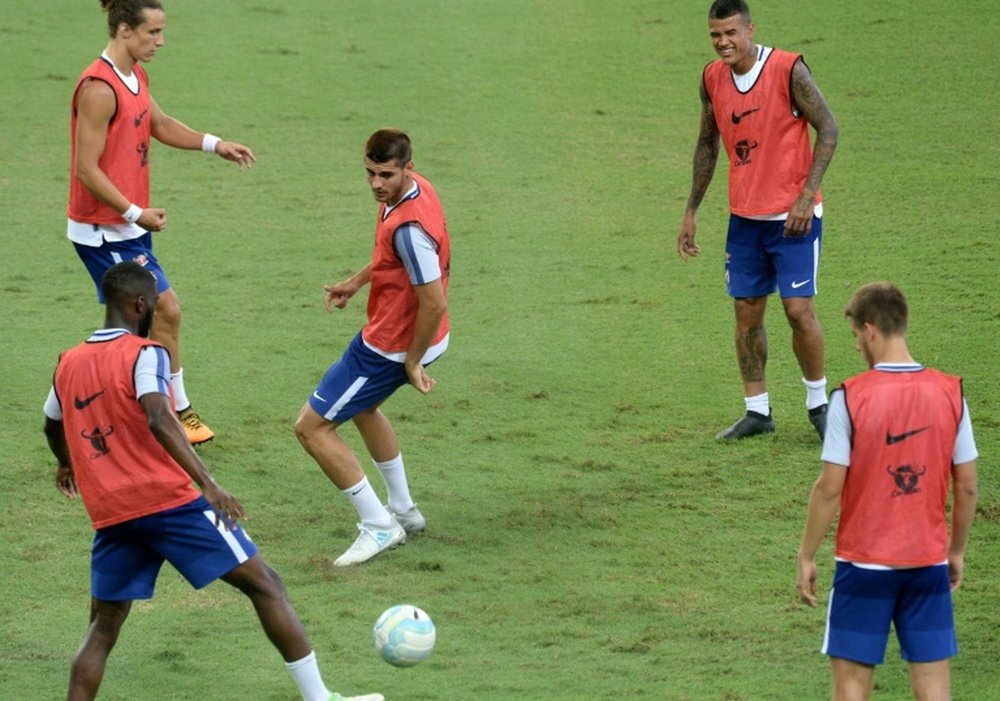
[797,283,978,699]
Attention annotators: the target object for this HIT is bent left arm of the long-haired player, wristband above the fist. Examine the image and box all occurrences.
[74,80,167,231]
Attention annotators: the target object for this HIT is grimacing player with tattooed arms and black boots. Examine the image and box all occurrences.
[677,0,838,440]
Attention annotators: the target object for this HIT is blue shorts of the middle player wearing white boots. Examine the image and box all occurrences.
[309,332,410,424]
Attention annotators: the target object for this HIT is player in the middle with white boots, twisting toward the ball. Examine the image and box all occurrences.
[295,129,451,566]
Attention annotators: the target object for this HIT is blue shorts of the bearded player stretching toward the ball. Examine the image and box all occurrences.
[90,496,257,601]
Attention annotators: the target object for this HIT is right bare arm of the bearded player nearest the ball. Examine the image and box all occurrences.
[139,392,246,528]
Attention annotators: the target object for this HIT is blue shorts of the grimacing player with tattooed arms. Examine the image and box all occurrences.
[726,214,823,298]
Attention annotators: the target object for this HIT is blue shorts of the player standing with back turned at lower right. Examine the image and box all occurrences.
[822,562,958,665]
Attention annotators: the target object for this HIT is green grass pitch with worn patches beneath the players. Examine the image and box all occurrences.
[0,0,1000,701]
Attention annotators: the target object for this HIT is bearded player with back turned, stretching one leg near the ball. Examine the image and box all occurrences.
[45,261,382,701]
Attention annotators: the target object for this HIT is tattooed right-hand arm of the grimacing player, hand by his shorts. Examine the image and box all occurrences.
[785,59,840,236]
